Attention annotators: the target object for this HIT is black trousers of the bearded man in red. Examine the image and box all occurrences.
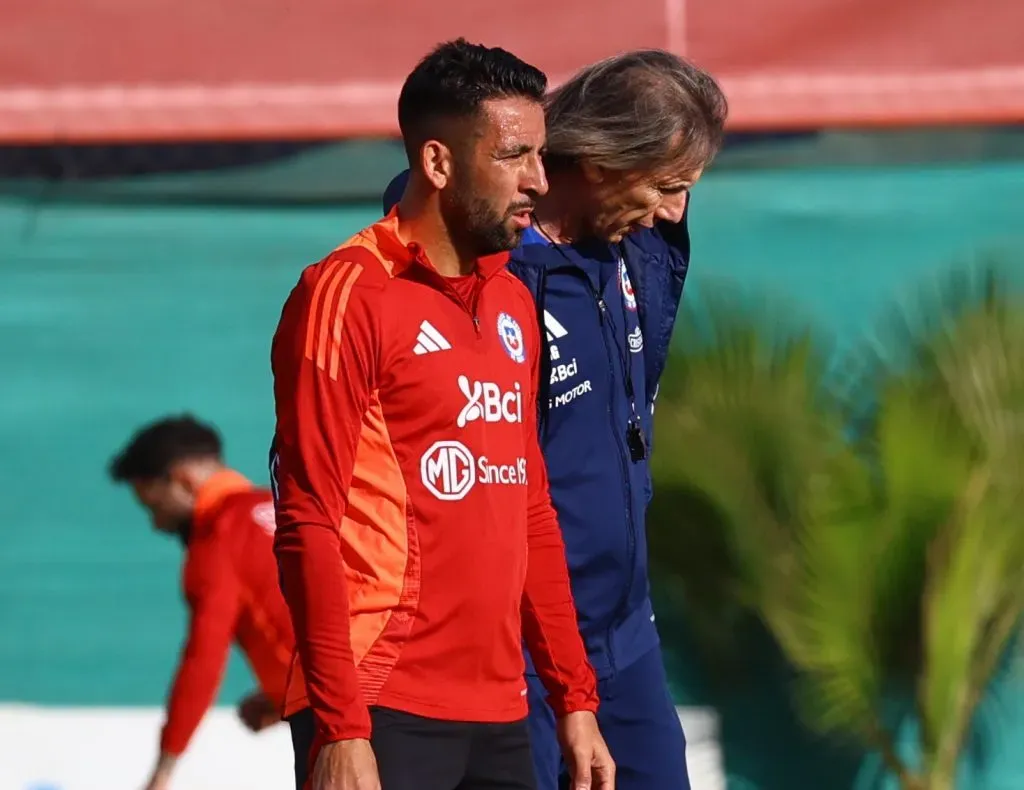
[288,707,537,790]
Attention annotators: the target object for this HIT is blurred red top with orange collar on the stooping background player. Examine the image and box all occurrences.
[161,470,295,754]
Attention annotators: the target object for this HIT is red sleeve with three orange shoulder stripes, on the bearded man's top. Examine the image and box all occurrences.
[271,256,380,743]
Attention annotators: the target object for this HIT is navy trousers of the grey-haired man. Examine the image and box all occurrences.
[527,649,690,790]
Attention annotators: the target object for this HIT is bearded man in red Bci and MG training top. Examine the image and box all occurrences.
[270,40,614,790]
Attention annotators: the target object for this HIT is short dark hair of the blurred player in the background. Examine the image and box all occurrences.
[110,414,221,483]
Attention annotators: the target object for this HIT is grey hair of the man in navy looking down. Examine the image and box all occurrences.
[545,49,728,177]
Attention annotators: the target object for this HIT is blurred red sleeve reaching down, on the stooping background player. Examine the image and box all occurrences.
[160,546,242,755]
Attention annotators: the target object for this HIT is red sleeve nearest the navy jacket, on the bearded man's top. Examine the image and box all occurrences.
[522,299,598,716]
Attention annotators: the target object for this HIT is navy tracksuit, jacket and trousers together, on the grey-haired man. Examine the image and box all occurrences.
[384,173,689,790]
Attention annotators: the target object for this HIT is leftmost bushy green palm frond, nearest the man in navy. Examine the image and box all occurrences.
[649,282,842,661]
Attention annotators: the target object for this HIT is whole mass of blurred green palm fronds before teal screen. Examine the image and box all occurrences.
[650,265,1024,788]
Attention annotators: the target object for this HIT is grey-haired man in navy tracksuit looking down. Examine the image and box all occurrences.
[384,50,727,790]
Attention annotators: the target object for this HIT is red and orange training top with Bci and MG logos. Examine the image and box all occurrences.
[271,206,597,742]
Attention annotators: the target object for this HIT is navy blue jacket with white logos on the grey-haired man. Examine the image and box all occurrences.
[384,173,689,677]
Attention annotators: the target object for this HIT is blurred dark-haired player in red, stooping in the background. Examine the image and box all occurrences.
[110,416,295,790]
